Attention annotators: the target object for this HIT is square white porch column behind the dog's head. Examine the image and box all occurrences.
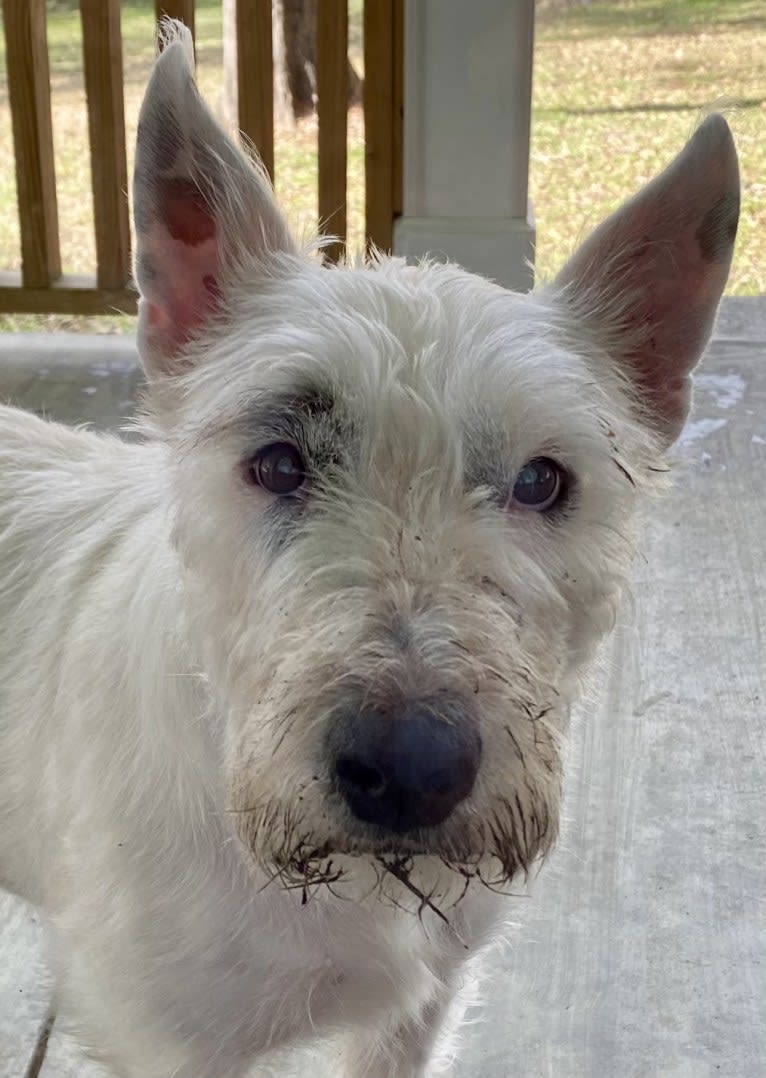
[393,0,534,290]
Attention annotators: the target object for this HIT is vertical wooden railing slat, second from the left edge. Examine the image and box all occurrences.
[80,0,130,289]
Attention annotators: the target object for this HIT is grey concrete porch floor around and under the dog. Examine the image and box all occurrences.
[0,299,766,1078]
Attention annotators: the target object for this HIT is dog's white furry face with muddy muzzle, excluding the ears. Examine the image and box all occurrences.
[149,263,642,892]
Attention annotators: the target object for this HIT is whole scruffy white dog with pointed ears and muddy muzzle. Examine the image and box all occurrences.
[0,26,739,1078]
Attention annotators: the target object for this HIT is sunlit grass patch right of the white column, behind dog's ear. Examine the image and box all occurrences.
[530,0,766,295]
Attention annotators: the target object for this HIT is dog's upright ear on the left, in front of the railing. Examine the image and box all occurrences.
[134,20,295,377]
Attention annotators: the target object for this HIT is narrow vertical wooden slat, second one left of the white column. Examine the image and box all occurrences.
[317,0,348,262]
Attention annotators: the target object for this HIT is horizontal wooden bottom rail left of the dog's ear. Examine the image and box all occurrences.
[0,273,138,315]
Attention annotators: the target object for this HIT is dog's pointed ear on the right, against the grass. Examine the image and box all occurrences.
[554,115,739,444]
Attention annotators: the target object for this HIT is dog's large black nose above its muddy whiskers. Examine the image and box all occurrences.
[333,706,482,832]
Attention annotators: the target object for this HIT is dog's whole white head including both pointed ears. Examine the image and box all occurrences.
[136,23,738,893]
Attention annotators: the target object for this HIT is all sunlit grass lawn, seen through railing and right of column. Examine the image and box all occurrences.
[0,0,766,332]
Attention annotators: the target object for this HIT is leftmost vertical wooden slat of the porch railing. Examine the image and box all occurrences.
[2,0,61,288]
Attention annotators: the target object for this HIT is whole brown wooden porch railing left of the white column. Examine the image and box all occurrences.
[0,0,402,315]
